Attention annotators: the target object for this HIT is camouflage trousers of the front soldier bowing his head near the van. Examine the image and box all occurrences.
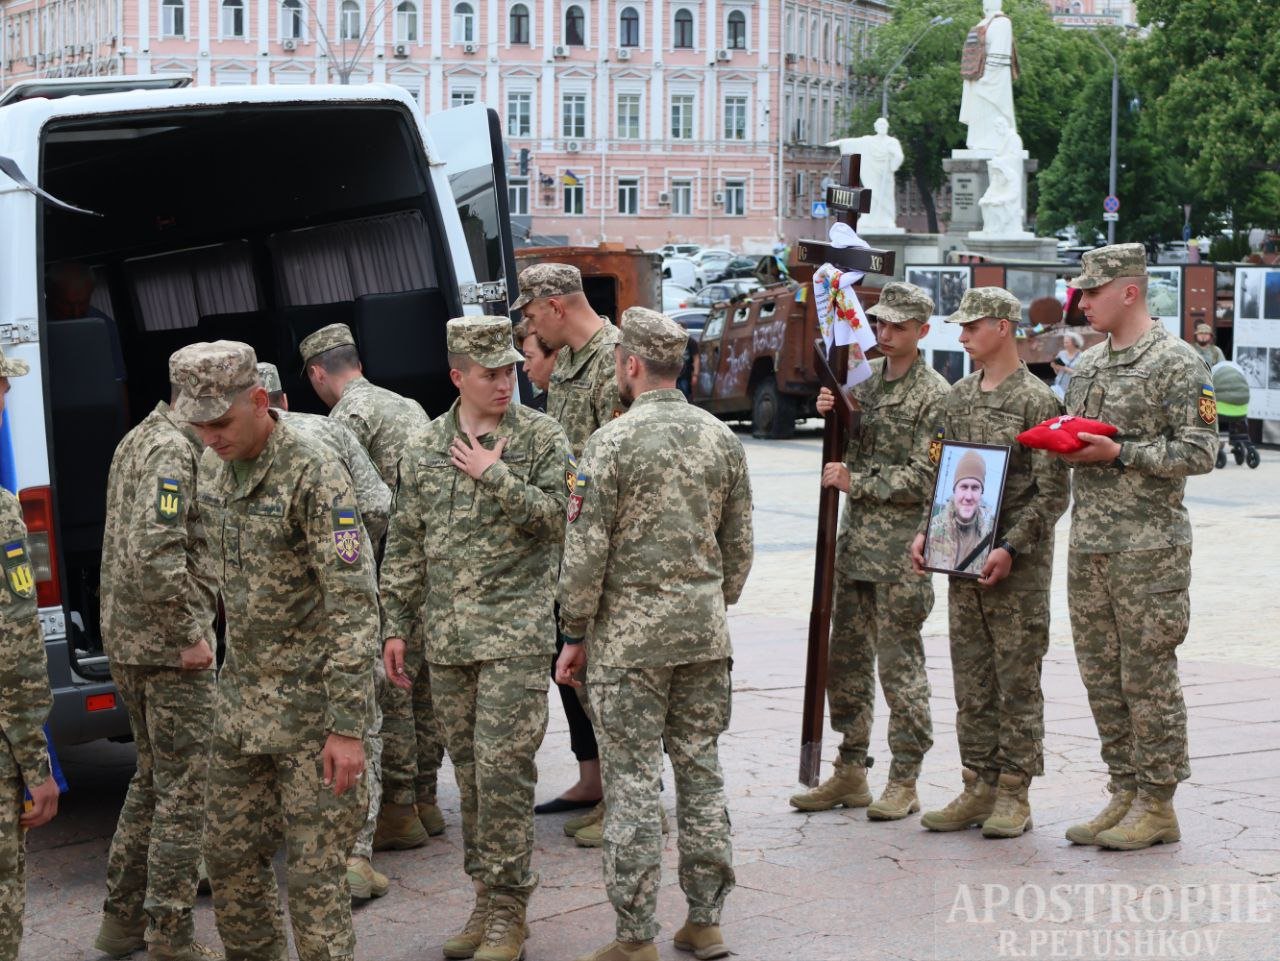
[205,737,369,961]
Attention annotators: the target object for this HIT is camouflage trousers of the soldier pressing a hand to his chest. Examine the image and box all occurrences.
[430,654,548,902]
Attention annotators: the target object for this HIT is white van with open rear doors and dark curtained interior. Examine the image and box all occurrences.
[0,78,516,743]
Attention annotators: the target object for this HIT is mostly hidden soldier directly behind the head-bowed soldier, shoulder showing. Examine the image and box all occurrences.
[257,363,392,900]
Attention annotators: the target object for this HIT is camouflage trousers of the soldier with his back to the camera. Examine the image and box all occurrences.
[588,659,733,941]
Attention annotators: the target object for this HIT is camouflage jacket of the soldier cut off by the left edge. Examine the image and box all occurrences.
[0,490,52,783]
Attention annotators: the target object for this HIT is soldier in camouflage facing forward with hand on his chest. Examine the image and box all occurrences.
[381,317,570,961]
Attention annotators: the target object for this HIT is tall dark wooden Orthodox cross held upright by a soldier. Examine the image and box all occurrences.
[796,154,895,787]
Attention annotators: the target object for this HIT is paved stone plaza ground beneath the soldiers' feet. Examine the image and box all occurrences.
[20,429,1280,961]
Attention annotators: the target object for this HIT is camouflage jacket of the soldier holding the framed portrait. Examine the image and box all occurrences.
[920,363,1079,590]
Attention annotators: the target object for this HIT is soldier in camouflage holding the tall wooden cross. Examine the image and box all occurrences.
[791,283,948,820]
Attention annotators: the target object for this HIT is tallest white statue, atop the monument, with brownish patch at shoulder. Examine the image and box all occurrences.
[960,0,1018,151]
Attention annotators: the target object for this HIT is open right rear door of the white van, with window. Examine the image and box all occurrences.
[426,104,517,314]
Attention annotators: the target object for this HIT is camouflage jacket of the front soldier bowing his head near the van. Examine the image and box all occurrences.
[197,422,379,754]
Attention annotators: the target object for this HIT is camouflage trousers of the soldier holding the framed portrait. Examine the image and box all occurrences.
[947,577,1048,777]
